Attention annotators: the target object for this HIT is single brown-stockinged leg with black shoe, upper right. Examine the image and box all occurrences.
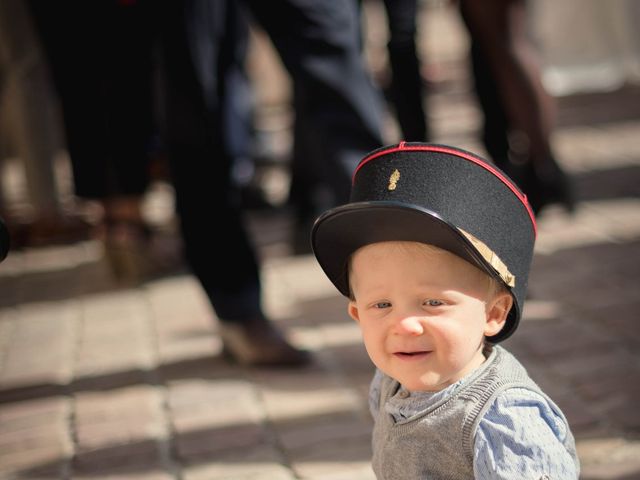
[460,0,574,212]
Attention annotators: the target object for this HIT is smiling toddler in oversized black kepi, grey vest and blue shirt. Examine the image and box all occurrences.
[312,142,579,480]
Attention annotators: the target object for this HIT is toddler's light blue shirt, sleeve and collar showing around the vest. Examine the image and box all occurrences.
[369,371,579,480]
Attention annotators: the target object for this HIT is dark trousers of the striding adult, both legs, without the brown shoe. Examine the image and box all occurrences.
[162,0,381,321]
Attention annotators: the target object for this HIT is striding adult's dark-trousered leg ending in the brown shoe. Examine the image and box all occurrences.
[162,0,309,365]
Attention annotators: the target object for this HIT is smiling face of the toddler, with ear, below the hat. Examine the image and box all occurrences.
[349,242,512,391]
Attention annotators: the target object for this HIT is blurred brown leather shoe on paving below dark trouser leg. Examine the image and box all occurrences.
[220,318,311,367]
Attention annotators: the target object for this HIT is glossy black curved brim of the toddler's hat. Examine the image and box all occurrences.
[311,201,520,342]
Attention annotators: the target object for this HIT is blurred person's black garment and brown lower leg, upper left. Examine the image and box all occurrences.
[30,0,161,279]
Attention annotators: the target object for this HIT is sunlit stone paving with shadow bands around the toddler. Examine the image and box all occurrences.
[0,3,640,480]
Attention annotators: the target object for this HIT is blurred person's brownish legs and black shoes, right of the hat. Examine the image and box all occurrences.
[460,0,575,213]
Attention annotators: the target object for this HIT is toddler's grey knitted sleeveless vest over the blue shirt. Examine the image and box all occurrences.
[373,347,575,480]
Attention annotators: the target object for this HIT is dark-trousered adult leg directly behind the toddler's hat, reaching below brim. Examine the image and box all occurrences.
[260,0,382,254]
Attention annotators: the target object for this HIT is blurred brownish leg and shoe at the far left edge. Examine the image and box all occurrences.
[0,0,89,247]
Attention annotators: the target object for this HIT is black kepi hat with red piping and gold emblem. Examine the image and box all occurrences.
[311,142,536,343]
